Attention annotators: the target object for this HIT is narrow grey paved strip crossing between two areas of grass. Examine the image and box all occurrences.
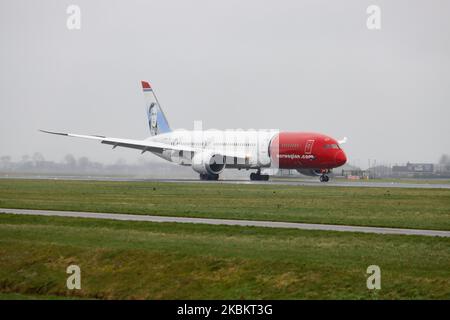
[0,208,450,237]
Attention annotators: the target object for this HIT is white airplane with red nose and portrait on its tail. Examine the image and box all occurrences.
[40,81,347,182]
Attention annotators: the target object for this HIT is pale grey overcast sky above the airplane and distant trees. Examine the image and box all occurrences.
[0,0,450,166]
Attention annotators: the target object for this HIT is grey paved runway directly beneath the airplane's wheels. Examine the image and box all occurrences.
[0,175,450,189]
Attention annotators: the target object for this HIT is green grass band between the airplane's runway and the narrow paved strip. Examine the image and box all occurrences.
[0,179,450,230]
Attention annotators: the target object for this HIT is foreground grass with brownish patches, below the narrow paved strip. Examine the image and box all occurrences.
[0,214,450,299]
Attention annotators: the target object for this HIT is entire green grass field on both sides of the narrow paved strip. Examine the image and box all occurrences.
[0,180,450,299]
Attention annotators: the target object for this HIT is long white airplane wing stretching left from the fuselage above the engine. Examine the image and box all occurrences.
[39,130,249,159]
